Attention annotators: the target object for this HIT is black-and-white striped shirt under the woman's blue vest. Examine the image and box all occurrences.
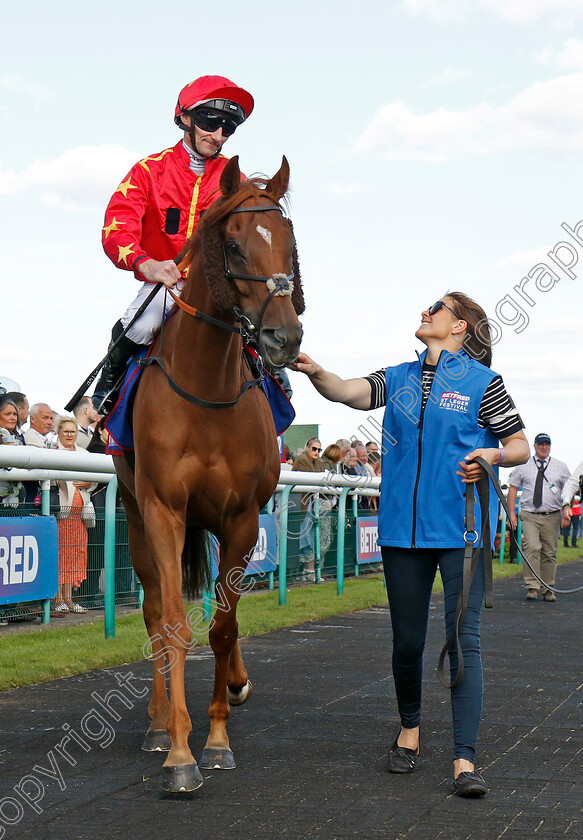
[365,363,524,438]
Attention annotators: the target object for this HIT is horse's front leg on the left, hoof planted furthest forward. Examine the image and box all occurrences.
[144,502,203,793]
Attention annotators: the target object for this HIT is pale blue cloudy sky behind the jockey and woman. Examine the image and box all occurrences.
[0,0,583,469]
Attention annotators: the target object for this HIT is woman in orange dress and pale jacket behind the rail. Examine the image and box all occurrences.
[51,417,95,617]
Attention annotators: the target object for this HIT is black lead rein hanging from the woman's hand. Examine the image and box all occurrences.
[437,458,583,689]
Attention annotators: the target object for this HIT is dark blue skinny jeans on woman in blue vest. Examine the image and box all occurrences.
[382,546,484,762]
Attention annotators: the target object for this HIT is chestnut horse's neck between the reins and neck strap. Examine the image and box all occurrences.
[163,278,242,399]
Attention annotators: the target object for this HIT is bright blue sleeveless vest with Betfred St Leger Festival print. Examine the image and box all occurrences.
[378,349,498,548]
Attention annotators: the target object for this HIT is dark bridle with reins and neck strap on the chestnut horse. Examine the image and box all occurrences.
[136,197,295,408]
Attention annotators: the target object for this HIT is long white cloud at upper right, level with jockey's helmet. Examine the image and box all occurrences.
[357,72,583,161]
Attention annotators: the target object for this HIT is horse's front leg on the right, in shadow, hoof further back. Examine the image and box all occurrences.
[200,515,258,770]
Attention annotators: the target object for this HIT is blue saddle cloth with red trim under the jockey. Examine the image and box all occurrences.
[105,347,296,455]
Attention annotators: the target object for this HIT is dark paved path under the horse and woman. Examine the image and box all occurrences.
[0,561,583,840]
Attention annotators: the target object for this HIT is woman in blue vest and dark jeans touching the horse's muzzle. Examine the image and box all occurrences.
[292,292,528,797]
